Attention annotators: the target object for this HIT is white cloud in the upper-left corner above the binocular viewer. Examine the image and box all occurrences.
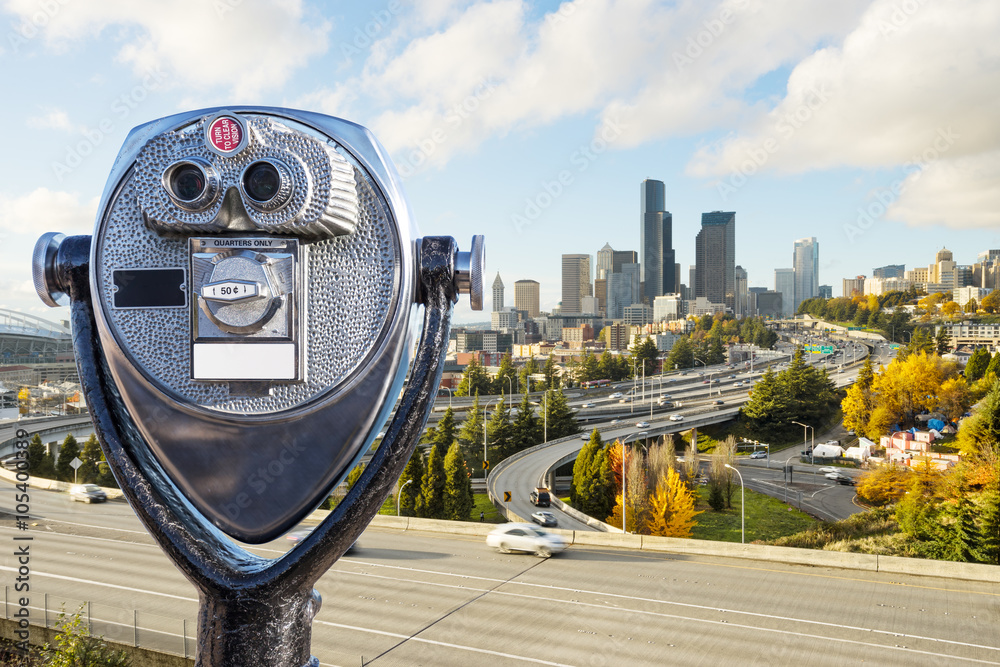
[6,0,330,100]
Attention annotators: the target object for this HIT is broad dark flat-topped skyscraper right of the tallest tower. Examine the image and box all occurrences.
[694,211,736,310]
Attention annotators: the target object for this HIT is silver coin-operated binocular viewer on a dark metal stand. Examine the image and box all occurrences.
[33,107,483,667]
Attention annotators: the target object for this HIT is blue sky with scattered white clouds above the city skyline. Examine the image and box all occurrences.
[0,0,1000,323]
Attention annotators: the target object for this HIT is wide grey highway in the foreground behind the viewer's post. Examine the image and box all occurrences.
[0,485,1000,667]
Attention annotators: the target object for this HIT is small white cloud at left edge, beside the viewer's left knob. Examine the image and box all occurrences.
[0,188,99,237]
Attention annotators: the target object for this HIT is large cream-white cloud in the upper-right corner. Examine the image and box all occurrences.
[688,0,1000,227]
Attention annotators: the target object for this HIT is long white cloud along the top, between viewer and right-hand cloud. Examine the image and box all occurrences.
[310,0,864,170]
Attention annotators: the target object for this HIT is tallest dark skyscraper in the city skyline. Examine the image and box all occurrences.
[639,178,677,303]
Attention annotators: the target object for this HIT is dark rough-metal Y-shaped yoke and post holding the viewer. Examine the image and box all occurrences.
[60,232,457,667]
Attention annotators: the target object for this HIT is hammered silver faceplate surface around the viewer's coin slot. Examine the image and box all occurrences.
[95,167,402,414]
